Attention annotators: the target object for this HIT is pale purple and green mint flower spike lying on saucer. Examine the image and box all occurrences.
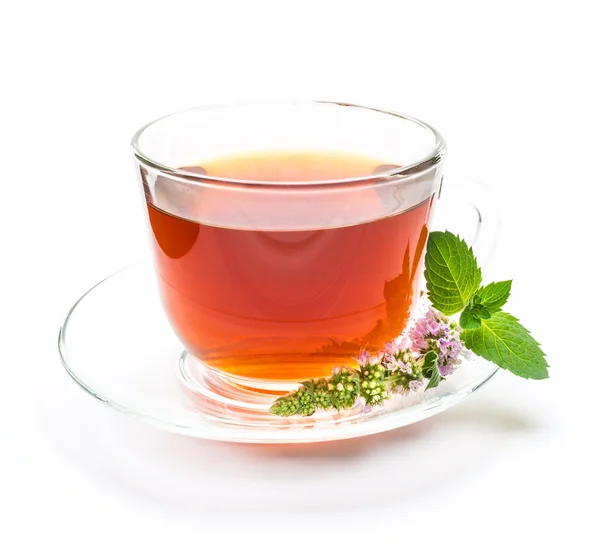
[271,308,463,417]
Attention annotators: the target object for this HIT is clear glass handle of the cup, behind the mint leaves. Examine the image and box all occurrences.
[439,175,501,266]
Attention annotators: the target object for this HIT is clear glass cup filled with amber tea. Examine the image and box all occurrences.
[132,102,492,397]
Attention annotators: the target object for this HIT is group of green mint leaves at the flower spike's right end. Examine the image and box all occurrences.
[423,231,548,380]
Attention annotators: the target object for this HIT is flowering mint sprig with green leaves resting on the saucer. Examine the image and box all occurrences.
[270,231,548,417]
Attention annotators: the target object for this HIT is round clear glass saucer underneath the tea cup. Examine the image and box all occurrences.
[59,262,497,443]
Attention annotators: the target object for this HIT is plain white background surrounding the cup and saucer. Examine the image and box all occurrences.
[0,0,600,543]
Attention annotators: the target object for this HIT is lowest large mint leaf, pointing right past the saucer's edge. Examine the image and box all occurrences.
[460,312,548,380]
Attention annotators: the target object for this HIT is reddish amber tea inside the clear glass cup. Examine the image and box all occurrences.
[148,152,433,381]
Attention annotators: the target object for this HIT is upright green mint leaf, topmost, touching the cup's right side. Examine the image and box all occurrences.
[425,231,481,315]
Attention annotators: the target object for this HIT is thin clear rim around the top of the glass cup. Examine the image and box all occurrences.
[130,100,446,188]
